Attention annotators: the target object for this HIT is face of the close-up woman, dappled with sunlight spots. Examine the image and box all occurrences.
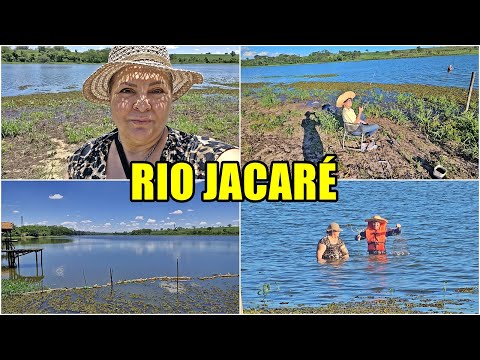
[110,65,172,144]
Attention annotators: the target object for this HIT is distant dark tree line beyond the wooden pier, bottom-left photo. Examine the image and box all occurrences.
[2,224,239,237]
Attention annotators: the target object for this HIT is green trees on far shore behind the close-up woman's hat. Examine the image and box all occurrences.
[2,46,239,64]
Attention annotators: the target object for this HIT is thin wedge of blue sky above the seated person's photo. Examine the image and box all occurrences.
[242,45,429,59]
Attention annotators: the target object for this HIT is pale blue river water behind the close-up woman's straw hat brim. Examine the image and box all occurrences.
[2,64,239,96]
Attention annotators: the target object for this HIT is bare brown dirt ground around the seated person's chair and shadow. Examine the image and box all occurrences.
[241,99,478,179]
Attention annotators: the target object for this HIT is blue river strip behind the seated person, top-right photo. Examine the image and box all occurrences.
[242,55,478,89]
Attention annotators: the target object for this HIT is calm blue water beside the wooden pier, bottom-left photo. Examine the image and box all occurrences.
[2,236,239,287]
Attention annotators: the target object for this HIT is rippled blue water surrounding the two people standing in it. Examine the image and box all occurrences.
[241,181,479,313]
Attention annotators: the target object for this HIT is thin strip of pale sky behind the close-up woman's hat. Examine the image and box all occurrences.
[19,45,240,54]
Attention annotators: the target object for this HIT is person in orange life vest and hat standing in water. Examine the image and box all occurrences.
[356,215,402,255]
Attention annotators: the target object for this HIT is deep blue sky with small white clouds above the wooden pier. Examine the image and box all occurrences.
[2,181,239,232]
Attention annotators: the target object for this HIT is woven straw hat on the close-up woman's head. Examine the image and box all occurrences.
[83,45,203,103]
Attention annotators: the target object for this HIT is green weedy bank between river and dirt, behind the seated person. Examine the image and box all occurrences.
[242,82,479,175]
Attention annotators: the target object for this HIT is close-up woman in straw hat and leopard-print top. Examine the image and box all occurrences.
[68,45,239,179]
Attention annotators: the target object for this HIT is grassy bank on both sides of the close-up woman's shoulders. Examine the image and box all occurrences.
[2,88,239,179]
